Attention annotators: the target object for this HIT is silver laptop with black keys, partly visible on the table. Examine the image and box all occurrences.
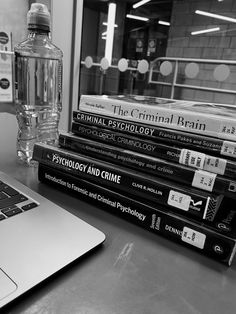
[0,172,105,308]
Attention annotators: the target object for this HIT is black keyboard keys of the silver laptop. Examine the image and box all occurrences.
[0,181,38,220]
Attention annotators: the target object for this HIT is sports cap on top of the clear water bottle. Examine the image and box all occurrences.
[27,3,50,31]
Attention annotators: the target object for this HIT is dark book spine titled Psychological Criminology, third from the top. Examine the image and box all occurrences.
[71,122,236,178]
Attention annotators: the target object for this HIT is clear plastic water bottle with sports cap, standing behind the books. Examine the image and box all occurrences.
[14,3,63,165]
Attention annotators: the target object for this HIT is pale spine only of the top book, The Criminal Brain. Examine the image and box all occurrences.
[79,95,236,141]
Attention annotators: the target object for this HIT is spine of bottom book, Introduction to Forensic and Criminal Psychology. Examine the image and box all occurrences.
[38,164,235,266]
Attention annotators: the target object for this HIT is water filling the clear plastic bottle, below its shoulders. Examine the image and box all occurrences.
[16,53,62,164]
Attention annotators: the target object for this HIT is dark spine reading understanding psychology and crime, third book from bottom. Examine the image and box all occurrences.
[59,134,236,199]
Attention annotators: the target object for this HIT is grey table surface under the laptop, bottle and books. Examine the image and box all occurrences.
[0,116,236,314]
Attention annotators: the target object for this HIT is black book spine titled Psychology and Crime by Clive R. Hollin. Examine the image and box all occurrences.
[33,143,222,220]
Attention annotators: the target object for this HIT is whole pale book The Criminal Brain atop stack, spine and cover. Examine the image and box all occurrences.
[79,95,236,141]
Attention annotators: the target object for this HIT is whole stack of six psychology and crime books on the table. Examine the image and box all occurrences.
[33,95,236,265]
